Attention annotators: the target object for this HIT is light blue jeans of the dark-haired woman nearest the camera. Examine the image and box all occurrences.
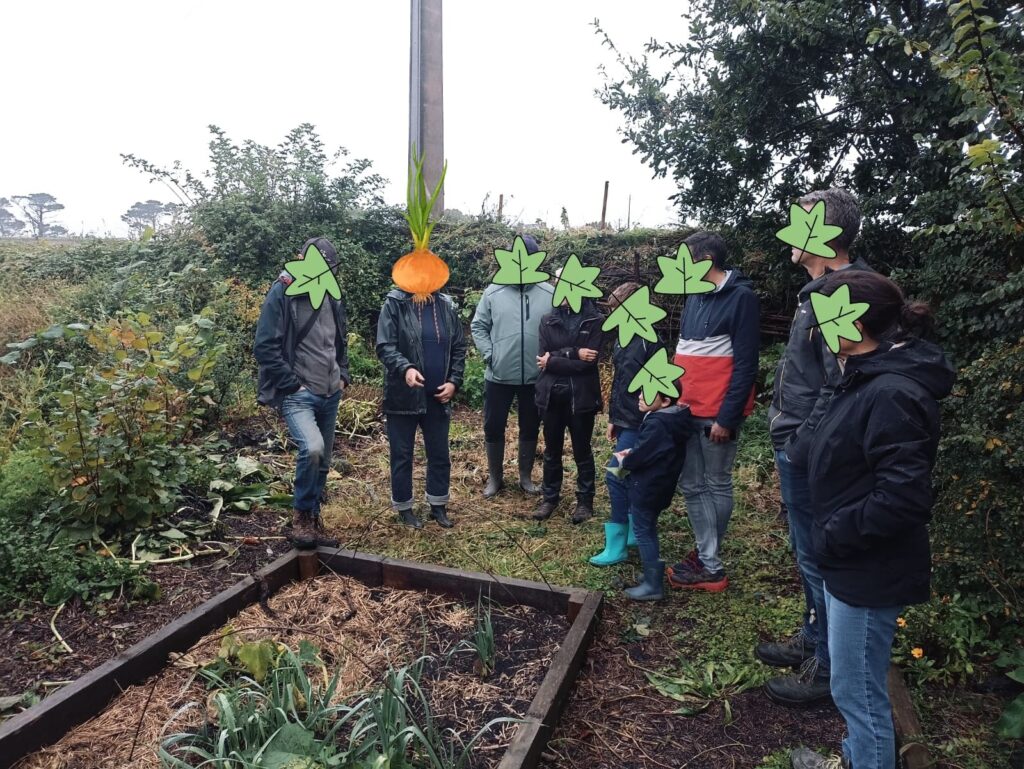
[825,588,903,769]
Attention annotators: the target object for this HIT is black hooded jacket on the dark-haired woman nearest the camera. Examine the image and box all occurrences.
[808,340,955,607]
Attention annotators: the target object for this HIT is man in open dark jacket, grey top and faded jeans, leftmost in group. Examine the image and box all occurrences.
[253,238,348,548]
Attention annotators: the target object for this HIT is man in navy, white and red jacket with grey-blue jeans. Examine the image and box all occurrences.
[669,232,761,592]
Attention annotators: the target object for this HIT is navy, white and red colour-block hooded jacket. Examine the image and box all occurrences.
[675,269,761,430]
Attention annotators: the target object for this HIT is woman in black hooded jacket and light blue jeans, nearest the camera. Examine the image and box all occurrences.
[793,270,954,769]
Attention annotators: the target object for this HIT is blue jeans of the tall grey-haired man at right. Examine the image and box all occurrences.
[775,452,827,671]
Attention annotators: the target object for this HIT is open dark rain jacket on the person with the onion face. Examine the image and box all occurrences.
[377,289,466,414]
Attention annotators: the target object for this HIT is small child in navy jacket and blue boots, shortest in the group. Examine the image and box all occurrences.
[614,393,691,601]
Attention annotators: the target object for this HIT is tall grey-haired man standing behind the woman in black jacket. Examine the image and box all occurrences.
[755,188,870,704]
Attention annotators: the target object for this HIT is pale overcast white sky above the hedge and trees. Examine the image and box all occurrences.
[0,0,685,234]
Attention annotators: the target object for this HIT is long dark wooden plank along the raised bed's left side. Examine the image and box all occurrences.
[0,551,298,769]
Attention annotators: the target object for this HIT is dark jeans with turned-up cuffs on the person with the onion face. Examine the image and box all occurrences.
[387,398,452,510]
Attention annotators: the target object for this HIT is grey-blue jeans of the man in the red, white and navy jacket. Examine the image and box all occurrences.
[678,417,739,571]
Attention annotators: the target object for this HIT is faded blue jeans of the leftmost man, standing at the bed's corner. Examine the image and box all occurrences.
[281,388,341,516]
